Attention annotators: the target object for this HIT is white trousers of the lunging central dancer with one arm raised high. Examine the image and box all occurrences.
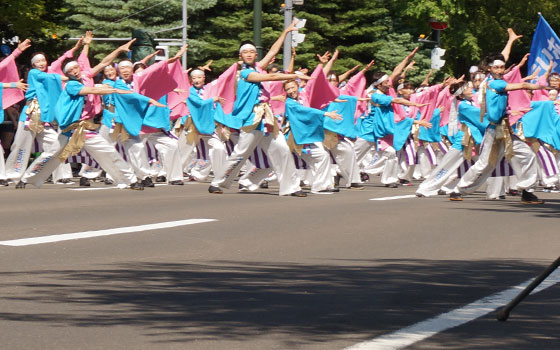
[212,130,301,196]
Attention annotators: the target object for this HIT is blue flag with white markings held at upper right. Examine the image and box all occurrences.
[529,14,560,76]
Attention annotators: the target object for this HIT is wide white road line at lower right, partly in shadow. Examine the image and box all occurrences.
[345,270,560,350]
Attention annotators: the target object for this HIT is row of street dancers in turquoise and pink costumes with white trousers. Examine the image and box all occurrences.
[0,22,560,204]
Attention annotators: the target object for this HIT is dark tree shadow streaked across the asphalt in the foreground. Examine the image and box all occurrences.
[0,260,560,349]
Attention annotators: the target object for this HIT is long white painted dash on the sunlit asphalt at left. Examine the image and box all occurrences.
[0,219,218,247]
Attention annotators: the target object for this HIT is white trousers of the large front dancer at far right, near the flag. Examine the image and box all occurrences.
[454,128,538,194]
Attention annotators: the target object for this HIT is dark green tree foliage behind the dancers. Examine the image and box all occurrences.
[4,0,560,83]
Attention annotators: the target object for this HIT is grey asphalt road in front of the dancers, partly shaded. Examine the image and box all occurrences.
[0,178,560,350]
